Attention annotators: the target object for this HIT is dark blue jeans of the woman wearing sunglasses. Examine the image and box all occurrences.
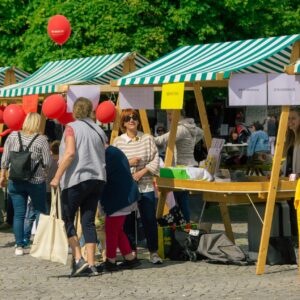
[124,192,158,252]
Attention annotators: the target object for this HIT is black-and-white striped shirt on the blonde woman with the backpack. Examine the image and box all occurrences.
[1,131,50,183]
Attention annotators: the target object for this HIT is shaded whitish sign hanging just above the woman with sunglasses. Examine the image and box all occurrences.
[119,87,154,109]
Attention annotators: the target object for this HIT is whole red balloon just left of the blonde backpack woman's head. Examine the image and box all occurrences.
[3,104,26,130]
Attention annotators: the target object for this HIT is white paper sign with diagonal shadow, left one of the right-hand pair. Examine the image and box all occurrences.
[229,74,267,106]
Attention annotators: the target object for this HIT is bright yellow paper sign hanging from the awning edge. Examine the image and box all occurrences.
[161,82,184,109]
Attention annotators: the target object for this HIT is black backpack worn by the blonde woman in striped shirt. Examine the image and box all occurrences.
[9,132,40,181]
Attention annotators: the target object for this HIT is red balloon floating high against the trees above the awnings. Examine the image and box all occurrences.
[48,15,71,45]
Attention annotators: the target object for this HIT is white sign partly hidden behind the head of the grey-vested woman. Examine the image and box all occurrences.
[67,85,100,112]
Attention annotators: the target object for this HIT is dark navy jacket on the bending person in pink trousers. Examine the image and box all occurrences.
[100,146,140,215]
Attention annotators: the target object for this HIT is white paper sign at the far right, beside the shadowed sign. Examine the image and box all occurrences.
[268,74,300,105]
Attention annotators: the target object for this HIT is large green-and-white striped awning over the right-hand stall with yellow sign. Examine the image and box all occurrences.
[117,34,300,86]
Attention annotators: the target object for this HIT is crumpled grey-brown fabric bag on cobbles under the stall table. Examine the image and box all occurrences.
[197,233,249,265]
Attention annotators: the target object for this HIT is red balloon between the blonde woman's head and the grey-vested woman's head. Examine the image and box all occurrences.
[42,94,67,119]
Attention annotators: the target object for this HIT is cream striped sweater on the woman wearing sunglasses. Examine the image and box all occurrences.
[113,131,159,193]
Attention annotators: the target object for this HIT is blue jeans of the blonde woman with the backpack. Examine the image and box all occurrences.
[8,180,46,247]
